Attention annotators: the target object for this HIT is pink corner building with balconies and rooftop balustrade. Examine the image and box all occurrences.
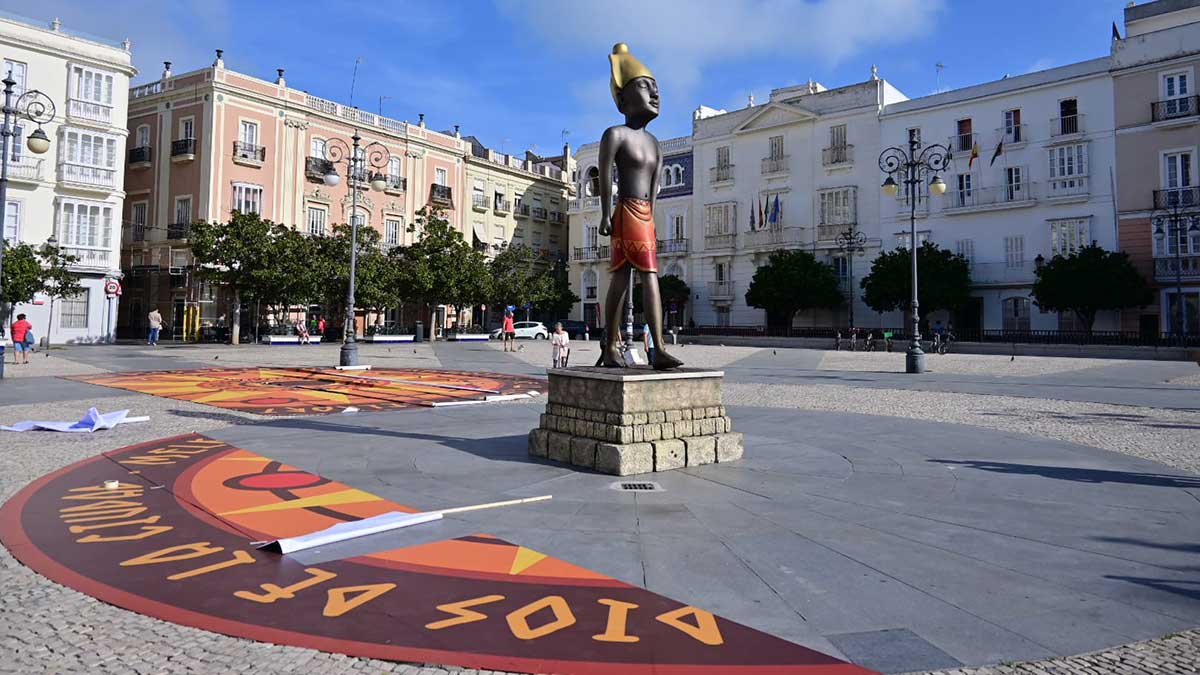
[119,52,470,340]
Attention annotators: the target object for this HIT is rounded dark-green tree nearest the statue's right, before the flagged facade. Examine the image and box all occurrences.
[745,251,845,327]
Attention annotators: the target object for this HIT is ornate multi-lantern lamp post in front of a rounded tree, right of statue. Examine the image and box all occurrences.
[880,137,952,374]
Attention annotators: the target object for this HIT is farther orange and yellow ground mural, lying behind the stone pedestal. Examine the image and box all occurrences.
[67,368,546,416]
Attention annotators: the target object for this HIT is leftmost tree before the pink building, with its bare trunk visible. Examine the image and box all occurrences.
[191,211,278,345]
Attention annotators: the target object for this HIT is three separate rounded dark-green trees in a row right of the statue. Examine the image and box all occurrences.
[745,241,1152,331]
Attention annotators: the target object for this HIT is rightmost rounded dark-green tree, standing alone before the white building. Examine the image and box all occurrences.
[1033,241,1153,333]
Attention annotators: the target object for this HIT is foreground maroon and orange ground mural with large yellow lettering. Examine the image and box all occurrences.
[0,434,871,675]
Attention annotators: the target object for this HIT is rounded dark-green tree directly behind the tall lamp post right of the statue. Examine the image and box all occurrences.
[859,241,971,324]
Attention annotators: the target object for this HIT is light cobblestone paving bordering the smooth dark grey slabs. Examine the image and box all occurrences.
[0,342,1200,675]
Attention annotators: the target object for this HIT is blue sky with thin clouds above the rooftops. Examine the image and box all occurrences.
[5,0,1126,154]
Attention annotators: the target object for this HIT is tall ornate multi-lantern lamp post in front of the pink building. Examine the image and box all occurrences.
[324,129,391,365]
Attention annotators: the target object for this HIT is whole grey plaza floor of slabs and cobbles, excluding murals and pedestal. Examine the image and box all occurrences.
[0,341,1200,675]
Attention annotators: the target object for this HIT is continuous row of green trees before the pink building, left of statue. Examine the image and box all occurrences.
[191,208,578,344]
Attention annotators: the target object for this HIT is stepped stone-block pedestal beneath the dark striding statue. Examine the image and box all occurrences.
[529,368,743,476]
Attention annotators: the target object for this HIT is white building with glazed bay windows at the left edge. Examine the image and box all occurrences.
[0,12,136,342]
